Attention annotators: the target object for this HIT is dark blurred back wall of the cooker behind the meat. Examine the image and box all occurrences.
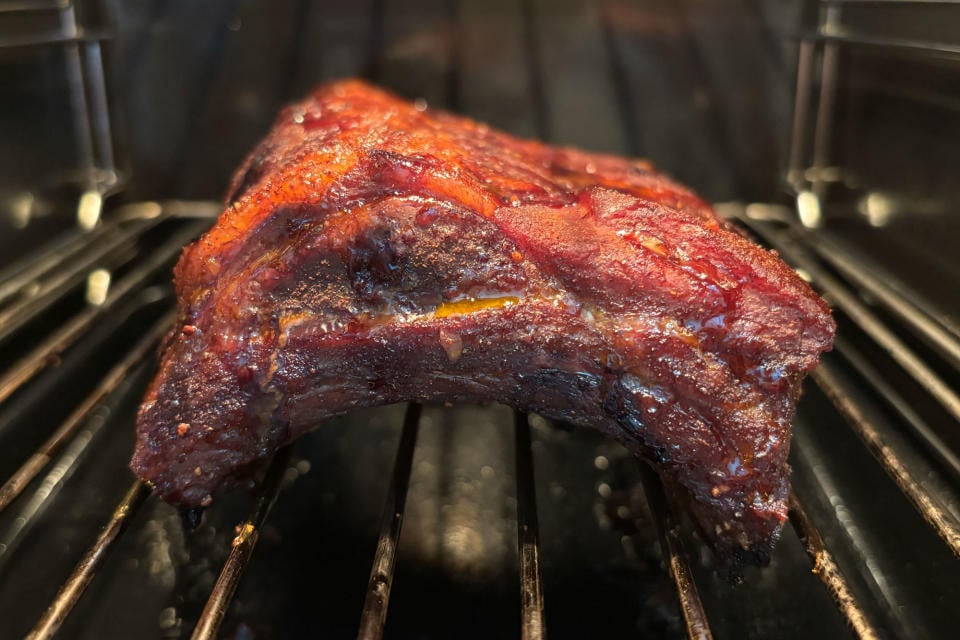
[103,0,798,205]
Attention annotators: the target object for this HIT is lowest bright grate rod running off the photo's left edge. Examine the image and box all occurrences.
[0,313,174,512]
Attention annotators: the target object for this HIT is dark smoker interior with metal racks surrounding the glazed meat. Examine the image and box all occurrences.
[0,0,960,638]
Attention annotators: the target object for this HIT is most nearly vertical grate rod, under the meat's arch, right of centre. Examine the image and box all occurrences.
[514,411,547,640]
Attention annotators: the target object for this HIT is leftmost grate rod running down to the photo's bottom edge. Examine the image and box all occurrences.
[27,480,150,640]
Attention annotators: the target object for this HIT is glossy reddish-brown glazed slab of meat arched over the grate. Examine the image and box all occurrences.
[132,81,834,561]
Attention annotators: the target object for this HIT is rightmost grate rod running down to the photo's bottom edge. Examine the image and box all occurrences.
[789,491,880,640]
